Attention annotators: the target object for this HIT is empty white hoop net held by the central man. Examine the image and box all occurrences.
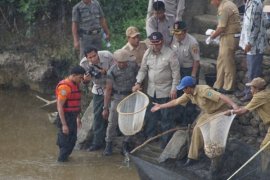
[117,91,149,136]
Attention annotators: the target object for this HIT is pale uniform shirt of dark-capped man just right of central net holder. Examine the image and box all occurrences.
[171,34,200,68]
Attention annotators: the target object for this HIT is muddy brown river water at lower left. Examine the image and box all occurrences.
[0,90,139,180]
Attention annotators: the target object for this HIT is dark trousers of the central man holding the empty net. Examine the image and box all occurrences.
[144,97,175,143]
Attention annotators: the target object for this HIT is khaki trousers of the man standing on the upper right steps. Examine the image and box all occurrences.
[214,34,238,90]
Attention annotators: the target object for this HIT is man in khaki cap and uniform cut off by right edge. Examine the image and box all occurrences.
[228,77,270,178]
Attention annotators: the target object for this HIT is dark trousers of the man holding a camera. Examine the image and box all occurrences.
[92,94,107,146]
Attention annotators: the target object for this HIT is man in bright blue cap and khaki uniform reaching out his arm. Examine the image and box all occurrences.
[151,76,238,166]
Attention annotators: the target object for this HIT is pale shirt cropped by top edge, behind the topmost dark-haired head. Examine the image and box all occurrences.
[147,0,185,21]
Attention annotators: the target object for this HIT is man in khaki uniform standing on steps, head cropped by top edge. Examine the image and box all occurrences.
[211,0,241,94]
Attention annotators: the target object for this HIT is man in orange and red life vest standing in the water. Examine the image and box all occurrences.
[55,66,85,162]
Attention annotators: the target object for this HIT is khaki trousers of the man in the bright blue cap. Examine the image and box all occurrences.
[188,108,227,160]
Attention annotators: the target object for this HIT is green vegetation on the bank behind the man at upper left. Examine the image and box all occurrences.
[0,0,148,52]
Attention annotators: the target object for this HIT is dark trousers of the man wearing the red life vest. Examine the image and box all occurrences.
[57,112,78,161]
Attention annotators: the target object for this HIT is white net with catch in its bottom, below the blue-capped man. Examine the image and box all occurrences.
[199,113,235,159]
